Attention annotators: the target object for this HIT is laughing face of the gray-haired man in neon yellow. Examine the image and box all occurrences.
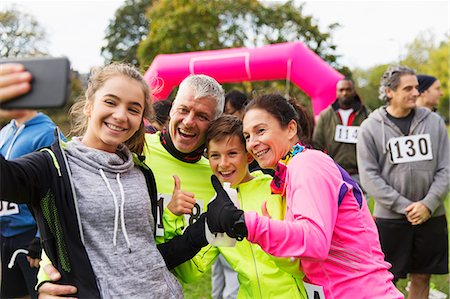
[169,88,217,153]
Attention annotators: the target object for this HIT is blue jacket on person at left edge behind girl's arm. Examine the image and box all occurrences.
[0,113,60,237]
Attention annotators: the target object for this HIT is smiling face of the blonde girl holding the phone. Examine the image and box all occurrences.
[82,75,145,153]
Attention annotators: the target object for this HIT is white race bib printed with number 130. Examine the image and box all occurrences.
[387,134,433,164]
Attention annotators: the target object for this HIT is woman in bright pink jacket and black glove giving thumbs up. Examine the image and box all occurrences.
[207,94,403,299]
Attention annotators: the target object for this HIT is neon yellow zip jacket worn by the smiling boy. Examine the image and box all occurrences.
[163,171,307,299]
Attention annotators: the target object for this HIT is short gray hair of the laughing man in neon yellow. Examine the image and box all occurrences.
[175,75,225,119]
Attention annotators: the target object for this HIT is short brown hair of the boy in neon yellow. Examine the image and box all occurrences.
[205,115,245,148]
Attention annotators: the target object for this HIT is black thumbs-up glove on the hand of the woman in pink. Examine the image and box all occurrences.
[206,175,248,240]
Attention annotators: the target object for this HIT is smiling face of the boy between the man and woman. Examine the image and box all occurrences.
[208,135,253,188]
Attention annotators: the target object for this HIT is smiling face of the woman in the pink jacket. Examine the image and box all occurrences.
[243,108,298,169]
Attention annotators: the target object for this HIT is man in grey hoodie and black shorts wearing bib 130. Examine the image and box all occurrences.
[357,66,449,298]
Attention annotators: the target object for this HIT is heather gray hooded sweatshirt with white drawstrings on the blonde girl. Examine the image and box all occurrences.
[65,138,183,299]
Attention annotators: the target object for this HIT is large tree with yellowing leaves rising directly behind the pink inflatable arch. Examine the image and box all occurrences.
[138,0,337,67]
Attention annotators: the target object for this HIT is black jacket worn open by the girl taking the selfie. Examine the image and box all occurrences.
[0,131,207,298]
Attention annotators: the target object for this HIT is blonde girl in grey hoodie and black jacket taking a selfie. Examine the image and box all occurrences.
[0,63,207,299]
